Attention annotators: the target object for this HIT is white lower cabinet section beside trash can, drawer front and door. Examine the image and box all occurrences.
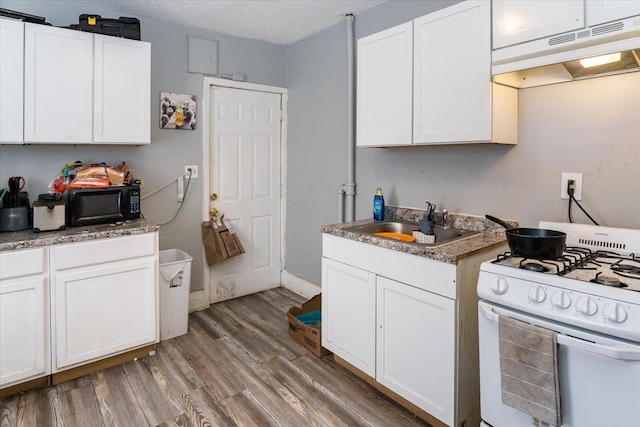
[51,233,158,372]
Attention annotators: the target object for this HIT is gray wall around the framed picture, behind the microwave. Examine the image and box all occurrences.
[0,0,286,290]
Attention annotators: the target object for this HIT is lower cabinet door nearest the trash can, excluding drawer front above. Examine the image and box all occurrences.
[52,257,157,372]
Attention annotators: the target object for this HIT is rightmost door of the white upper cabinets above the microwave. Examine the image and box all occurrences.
[93,34,151,144]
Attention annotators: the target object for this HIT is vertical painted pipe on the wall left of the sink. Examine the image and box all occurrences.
[344,14,356,222]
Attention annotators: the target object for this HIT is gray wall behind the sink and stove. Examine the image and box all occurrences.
[286,1,640,284]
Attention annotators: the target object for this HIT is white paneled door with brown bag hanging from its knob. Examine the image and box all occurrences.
[209,87,282,303]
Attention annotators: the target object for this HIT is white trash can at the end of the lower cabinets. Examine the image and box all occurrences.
[159,249,193,341]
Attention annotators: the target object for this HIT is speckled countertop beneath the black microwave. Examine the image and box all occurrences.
[0,219,160,251]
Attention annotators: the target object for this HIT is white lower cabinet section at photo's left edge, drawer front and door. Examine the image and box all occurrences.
[0,248,51,388]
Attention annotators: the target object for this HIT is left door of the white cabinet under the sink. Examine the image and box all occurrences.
[322,258,376,377]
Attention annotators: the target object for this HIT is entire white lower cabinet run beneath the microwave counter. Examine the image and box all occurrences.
[0,232,159,388]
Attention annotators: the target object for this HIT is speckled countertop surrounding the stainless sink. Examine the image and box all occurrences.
[321,206,518,264]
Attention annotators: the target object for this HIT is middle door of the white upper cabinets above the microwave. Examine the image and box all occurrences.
[24,24,93,143]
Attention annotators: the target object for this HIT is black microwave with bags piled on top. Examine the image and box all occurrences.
[67,185,140,227]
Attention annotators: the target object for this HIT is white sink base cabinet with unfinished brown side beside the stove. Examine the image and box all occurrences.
[322,234,506,426]
